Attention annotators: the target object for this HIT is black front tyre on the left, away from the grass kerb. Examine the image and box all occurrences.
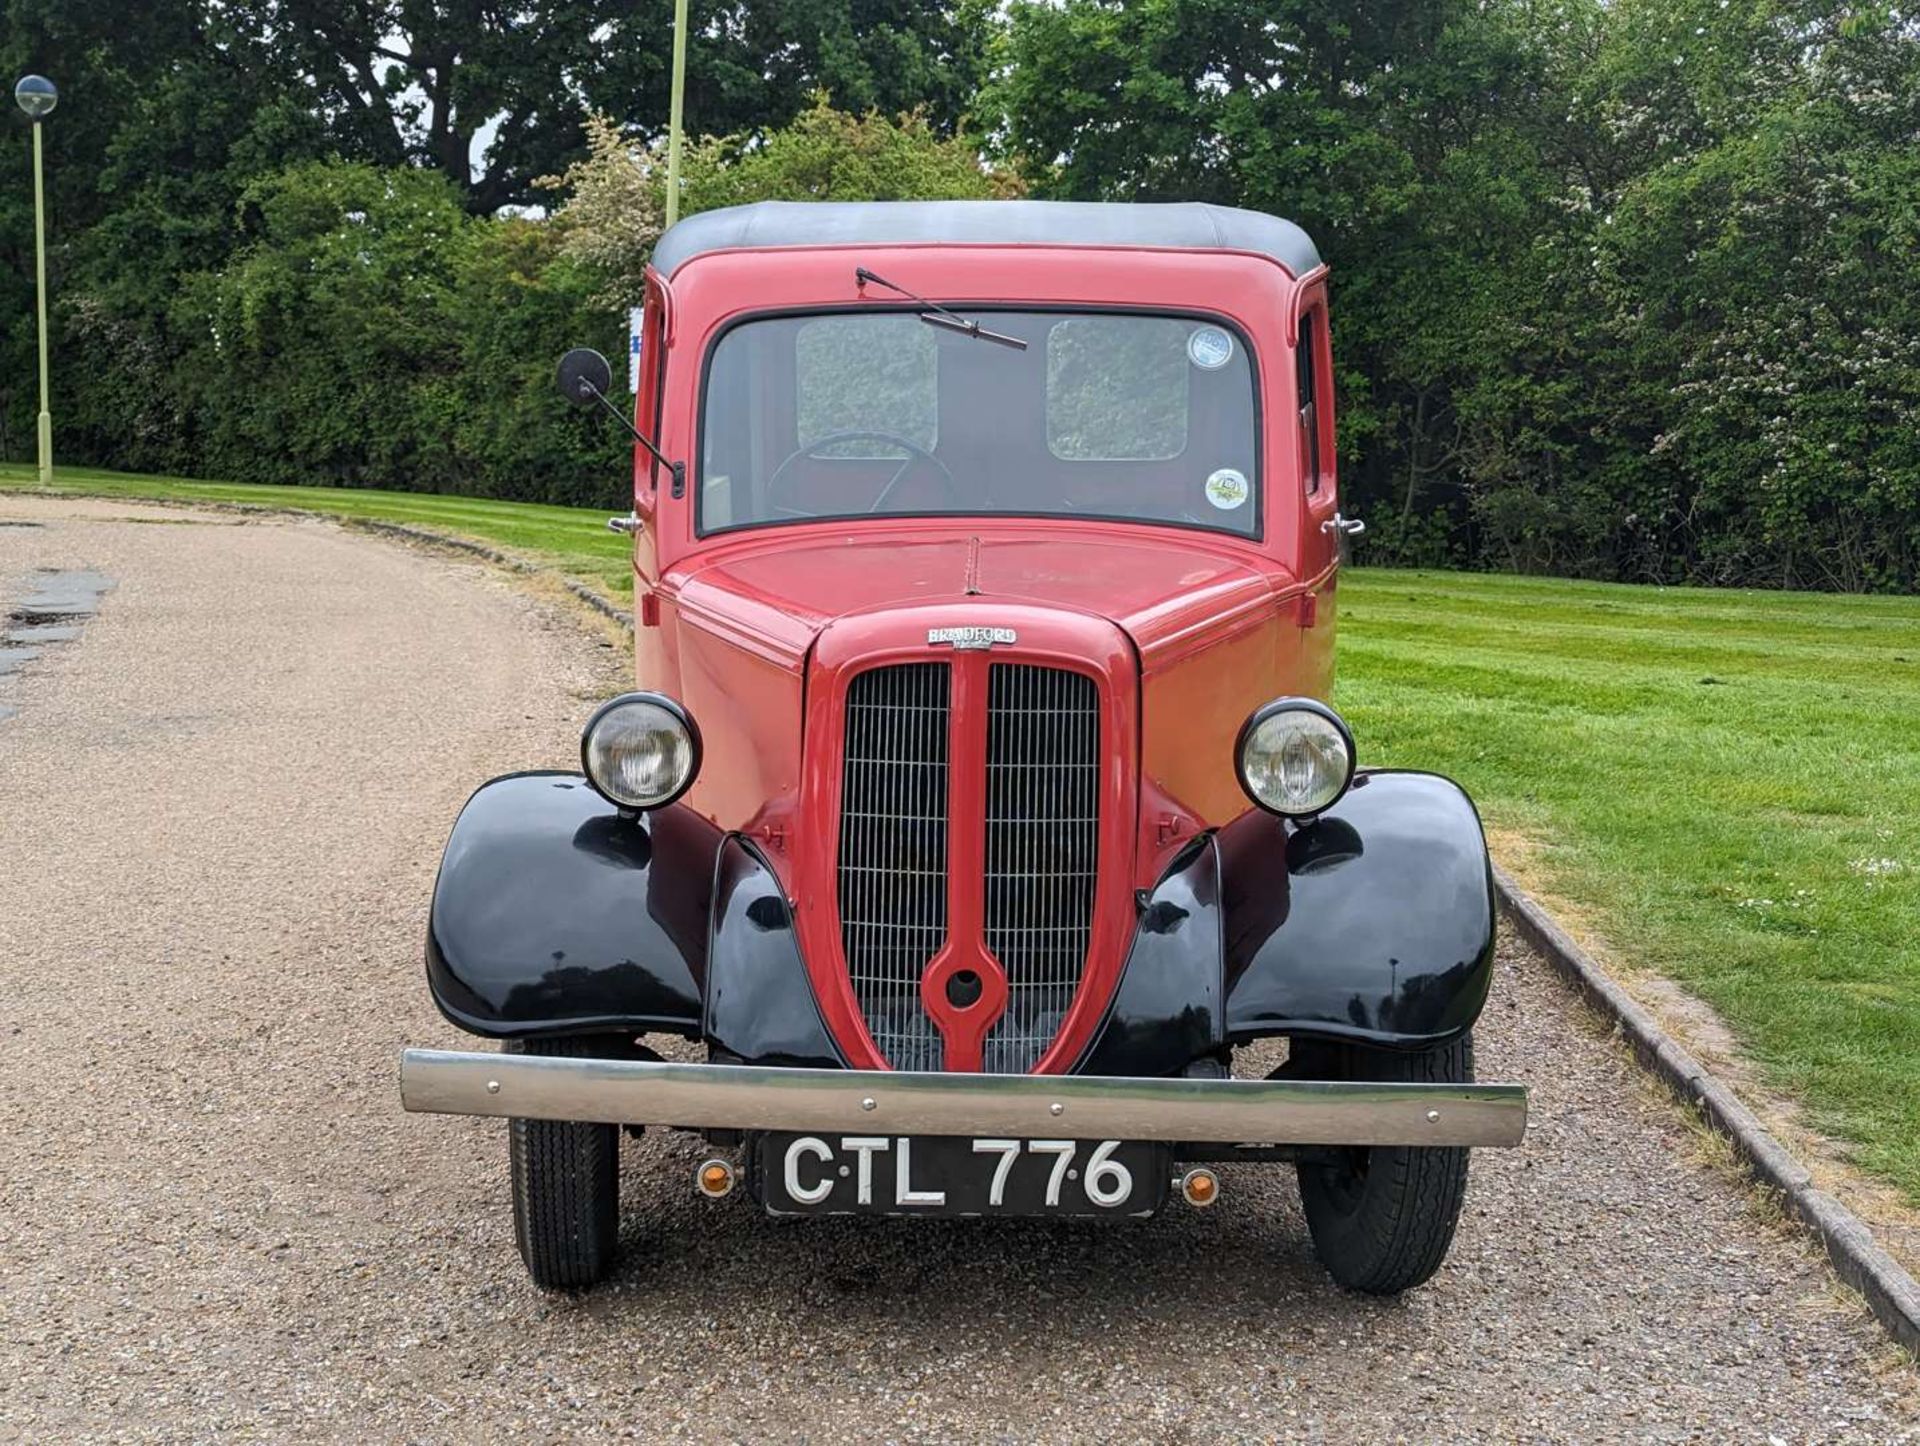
[507,1035,630,1290]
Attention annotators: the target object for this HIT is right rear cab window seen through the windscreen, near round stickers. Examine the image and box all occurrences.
[1046,317,1192,463]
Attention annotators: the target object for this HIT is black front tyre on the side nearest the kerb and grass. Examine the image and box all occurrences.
[1288,1033,1473,1296]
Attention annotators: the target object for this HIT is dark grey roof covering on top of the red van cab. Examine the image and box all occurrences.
[653,202,1319,277]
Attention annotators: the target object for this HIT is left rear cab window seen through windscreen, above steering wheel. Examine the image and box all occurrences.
[793,315,939,457]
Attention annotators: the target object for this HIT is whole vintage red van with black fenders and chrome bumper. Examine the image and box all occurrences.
[401,202,1526,1292]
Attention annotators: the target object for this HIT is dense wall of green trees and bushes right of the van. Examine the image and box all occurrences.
[995,0,1920,590]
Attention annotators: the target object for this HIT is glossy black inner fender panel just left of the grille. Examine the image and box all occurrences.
[705,837,845,1070]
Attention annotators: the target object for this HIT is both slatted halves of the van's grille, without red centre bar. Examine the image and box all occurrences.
[837,663,1100,1073]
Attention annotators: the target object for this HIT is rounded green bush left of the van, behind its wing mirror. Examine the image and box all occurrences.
[153,161,622,503]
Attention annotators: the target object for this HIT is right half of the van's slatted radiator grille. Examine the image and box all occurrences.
[983,663,1100,1073]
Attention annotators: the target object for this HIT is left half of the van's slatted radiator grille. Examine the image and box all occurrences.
[839,663,950,1070]
